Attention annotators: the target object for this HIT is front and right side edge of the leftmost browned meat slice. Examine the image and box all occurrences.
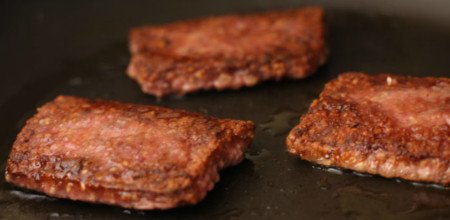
[5,117,254,210]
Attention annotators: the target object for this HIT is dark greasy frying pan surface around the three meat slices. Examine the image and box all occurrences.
[0,0,450,219]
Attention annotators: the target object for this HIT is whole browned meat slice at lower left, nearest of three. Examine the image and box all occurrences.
[5,96,254,209]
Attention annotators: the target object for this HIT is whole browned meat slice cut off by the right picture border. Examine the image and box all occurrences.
[287,73,450,185]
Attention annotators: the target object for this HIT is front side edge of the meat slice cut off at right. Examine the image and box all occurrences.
[286,132,450,186]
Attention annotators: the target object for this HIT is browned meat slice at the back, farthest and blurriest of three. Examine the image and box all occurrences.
[128,7,327,97]
